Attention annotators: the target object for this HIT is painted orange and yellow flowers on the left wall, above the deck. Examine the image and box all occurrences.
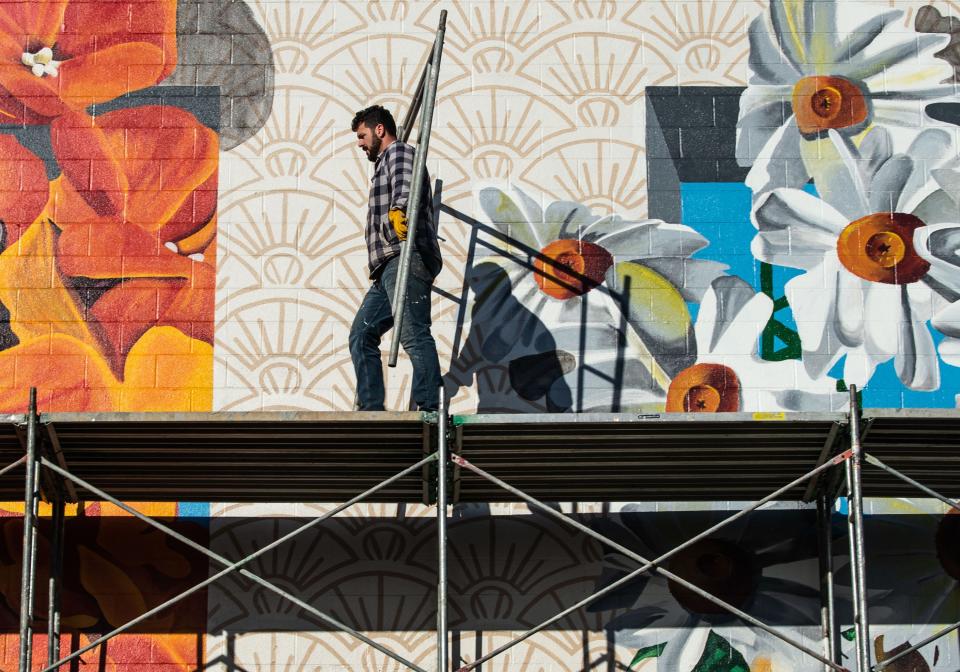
[0,5,219,412]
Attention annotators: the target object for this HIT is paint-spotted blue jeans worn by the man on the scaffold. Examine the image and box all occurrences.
[350,254,441,411]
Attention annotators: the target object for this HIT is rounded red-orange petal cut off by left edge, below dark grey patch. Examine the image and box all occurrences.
[0,134,50,247]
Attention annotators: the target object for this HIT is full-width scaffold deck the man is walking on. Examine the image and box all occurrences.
[0,409,960,502]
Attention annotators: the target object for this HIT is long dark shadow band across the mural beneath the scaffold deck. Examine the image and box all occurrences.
[0,505,960,671]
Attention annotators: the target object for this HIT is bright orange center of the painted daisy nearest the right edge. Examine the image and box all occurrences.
[837,212,930,285]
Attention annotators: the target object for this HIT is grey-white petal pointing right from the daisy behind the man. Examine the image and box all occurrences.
[584,219,709,260]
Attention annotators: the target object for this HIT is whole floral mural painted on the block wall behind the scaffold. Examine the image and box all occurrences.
[0,0,960,672]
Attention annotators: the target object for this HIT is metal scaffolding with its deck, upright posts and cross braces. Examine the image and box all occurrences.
[0,402,960,672]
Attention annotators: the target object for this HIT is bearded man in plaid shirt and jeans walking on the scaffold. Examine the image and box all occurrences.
[350,105,443,411]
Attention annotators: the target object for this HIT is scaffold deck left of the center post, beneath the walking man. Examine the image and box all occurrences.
[0,412,436,502]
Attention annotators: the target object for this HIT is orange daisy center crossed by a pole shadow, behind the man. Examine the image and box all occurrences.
[533,239,613,299]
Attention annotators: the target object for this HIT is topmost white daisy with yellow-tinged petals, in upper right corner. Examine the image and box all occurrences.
[737,0,955,198]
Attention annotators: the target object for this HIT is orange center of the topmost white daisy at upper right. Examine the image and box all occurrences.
[793,76,868,134]
